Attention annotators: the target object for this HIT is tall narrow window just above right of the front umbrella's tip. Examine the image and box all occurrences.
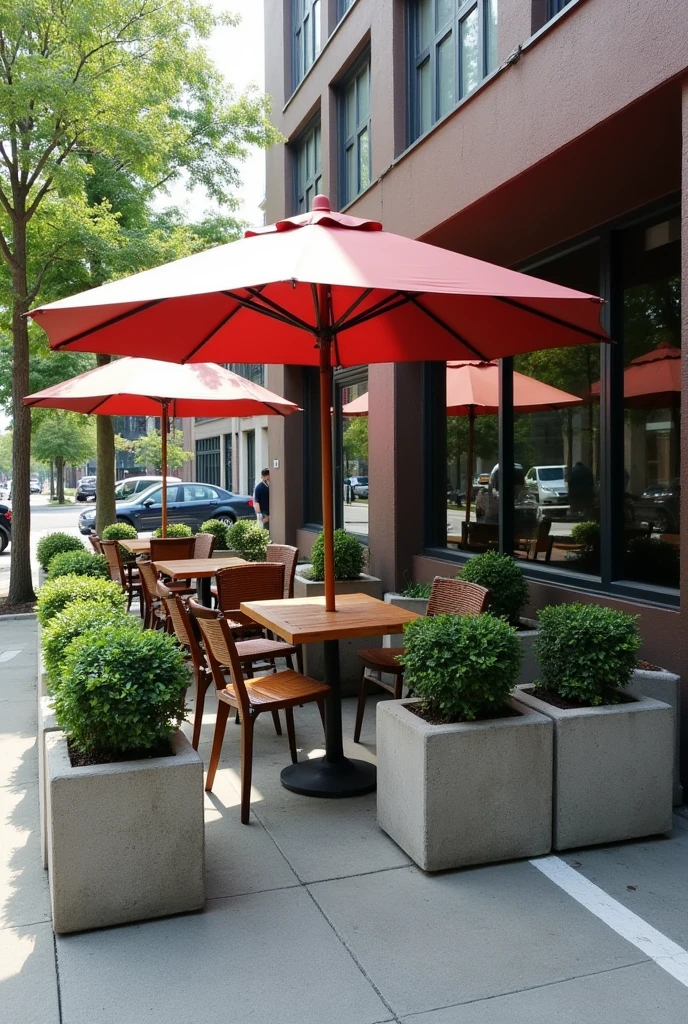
[340,54,371,206]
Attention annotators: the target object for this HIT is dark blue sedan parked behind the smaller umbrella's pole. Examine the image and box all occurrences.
[79,482,256,535]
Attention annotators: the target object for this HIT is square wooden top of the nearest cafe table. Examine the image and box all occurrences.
[241,594,420,644]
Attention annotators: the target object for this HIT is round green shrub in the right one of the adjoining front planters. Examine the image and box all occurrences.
[535,604,641,705]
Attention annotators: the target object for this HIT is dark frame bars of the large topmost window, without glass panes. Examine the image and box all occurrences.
[406,0,499,145]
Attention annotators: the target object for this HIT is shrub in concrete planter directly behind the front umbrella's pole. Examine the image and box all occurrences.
[294,529,382,696]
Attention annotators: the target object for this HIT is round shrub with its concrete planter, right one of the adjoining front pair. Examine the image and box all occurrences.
[516,604,674,850]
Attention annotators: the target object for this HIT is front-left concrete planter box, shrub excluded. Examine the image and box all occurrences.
[45,730,205,934]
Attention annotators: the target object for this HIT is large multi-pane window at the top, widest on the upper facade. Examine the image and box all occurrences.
[409,0,498,140]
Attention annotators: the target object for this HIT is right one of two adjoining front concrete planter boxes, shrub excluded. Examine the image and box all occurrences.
[515,689,674,850]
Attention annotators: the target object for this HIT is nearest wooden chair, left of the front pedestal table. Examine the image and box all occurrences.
[189,602,330,825]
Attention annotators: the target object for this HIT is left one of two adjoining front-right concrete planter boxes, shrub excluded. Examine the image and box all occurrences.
[377,700,553,871]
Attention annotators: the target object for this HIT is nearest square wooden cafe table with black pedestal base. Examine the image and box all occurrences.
[241,594,420,797]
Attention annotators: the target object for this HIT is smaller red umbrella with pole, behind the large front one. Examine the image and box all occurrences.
[24,357,299,537]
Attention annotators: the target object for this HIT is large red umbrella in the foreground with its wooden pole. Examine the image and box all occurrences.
[32,196,608,610]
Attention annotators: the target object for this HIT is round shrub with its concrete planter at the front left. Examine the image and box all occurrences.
[46,625,204,934]
